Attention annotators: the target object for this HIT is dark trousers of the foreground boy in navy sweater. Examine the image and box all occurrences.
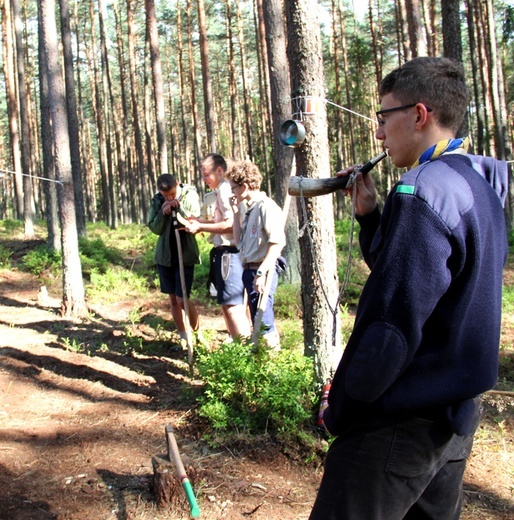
[309,406,479,520]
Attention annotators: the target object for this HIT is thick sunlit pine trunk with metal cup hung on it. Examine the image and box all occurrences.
[285,0,340,384]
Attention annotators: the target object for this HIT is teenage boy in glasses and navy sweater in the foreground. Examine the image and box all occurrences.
[310,54,507,520]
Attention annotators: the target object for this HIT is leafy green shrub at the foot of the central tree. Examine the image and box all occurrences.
[196,341,316,436]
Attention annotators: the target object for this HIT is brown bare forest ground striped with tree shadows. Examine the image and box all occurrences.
[0,270,514,520]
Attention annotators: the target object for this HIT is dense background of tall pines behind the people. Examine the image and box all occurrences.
[0,0,514,229]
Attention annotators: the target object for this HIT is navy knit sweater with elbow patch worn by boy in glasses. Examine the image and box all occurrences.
[324,154,508,435]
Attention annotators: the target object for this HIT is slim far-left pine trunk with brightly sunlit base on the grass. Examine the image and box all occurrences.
[11,0,35,238]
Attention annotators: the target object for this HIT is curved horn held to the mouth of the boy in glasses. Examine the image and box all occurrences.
[288,151,387,197]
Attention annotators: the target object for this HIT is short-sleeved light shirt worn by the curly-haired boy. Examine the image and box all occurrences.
[238,191,286,264]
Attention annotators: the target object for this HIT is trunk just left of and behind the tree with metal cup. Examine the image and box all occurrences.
[263,0,301,283]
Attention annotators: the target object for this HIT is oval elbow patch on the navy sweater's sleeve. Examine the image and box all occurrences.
[345,323,407,403]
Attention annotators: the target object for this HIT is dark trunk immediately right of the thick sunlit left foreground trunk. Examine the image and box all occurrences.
[59,0,86,237]
